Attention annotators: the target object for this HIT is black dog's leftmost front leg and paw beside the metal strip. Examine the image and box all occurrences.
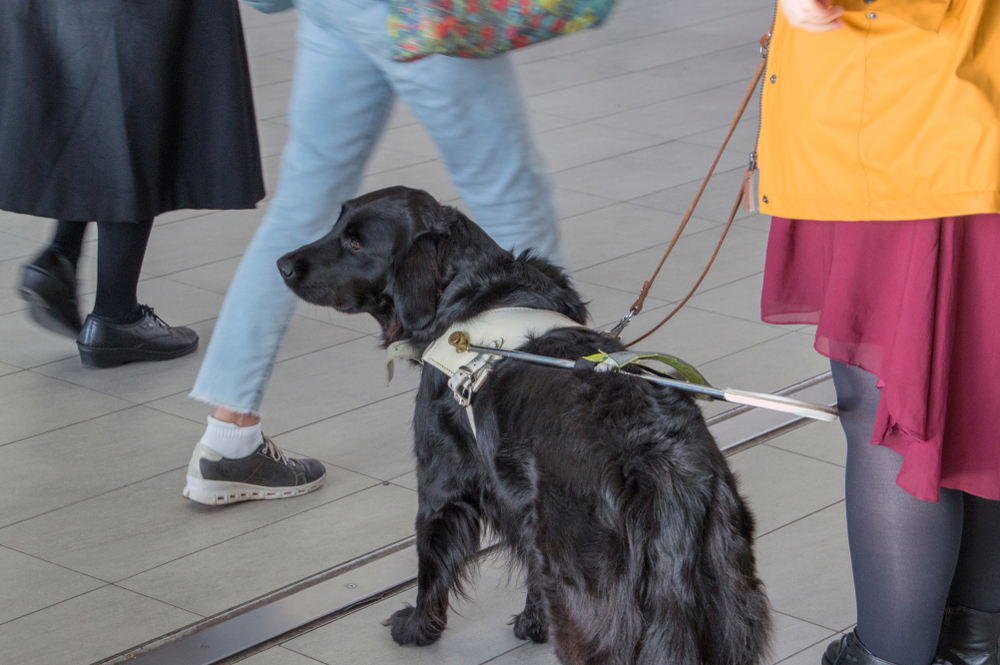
[386,501,480,646]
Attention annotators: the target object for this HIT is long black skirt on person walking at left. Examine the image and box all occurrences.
[0,0,264,222]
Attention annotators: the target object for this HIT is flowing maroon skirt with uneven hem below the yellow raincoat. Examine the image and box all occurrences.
[761,214,1000,501]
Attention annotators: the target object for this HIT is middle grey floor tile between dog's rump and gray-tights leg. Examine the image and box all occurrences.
[757,503,857,630]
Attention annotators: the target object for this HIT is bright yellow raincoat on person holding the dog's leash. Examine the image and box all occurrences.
[757,0,1000,221]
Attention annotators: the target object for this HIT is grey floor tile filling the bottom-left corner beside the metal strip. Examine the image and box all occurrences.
[0,586,200,665]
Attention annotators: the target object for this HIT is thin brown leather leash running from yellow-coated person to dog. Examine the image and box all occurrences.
[624,24,774,347]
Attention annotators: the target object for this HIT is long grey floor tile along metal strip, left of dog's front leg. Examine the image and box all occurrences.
[120,485,417,616]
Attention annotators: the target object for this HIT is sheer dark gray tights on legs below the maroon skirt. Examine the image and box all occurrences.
[831,362,1000,665]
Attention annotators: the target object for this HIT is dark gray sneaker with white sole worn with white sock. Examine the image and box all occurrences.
[184,436,326,506]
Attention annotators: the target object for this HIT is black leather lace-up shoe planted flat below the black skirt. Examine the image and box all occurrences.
[76,305,198,367]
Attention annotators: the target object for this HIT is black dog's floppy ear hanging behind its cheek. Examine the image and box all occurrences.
[388,236,441,331]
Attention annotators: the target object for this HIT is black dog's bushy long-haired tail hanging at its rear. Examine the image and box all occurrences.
[634,469,771,665]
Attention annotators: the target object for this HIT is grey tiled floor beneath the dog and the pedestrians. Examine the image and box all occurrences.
[0,0,854,665]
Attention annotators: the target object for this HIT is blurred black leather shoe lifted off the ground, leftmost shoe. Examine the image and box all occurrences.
[18,247,83,337]
